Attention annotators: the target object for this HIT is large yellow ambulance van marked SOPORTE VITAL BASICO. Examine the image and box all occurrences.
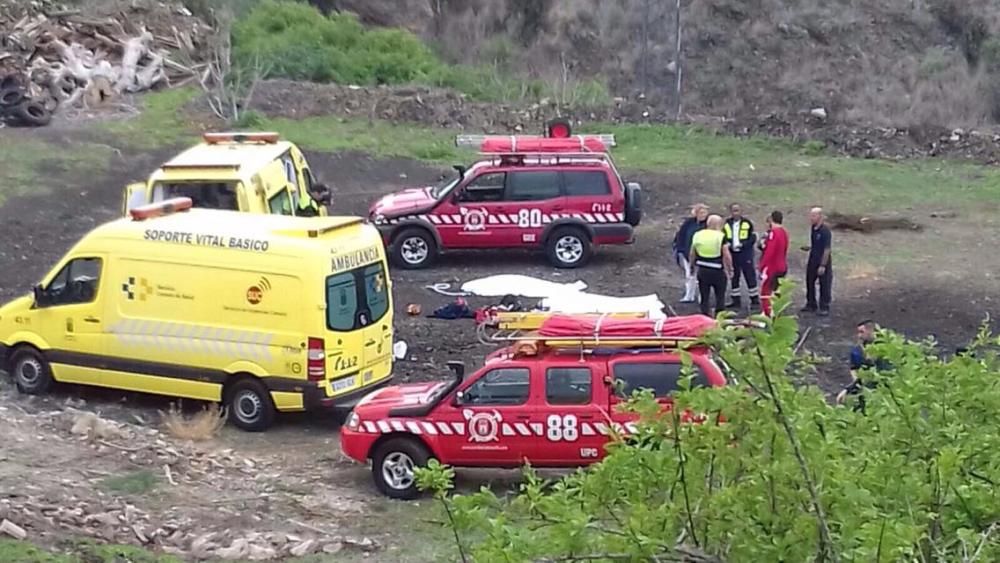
[0,198,393,431]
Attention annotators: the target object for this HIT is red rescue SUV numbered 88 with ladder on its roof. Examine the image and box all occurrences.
[340,315,727,499]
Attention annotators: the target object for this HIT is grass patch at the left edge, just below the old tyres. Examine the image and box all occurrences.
[0,136,113,204]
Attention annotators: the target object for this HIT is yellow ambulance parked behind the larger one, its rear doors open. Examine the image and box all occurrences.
[122,133,330,217]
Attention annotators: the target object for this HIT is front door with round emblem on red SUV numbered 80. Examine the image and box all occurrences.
[438,171,514,248]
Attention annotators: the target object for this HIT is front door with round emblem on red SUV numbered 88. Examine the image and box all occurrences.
[433,362,532,467]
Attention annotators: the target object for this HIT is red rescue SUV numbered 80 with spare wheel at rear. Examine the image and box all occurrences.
[369,122,642,269]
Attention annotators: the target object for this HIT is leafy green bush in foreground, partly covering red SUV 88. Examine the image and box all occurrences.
[420,290,1000,562]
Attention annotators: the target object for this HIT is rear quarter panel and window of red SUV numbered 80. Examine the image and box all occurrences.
[562,166,625,225]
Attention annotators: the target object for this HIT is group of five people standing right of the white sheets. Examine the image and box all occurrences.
[673,203,833,316]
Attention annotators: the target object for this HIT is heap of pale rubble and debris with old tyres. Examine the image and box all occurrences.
[0,0,212,126]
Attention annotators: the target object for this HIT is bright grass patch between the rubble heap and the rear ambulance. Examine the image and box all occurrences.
[96,88,198,150]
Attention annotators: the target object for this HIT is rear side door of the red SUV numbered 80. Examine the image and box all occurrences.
[500,169,566,247]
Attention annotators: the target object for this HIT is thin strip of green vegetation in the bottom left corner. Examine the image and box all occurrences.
[0,540,180,563]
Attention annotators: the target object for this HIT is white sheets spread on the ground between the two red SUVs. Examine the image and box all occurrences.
[462,274,666,319]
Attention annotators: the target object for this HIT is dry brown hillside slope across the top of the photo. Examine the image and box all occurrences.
[313,0,1000,127]
